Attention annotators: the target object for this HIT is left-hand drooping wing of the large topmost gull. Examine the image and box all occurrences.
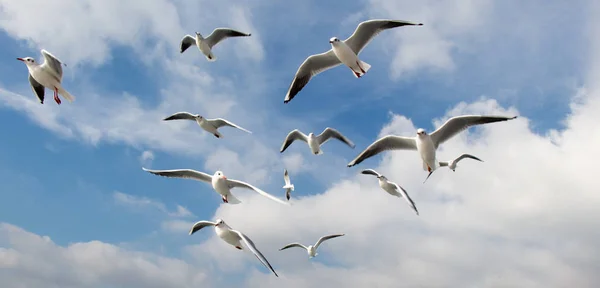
[283,50,342,103]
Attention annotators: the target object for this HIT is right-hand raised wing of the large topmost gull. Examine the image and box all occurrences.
[344,19,423,55]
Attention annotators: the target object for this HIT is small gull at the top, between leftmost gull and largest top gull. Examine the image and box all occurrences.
[180,28,252,62]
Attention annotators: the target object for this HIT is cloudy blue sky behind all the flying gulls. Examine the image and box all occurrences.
[0,0,600,288]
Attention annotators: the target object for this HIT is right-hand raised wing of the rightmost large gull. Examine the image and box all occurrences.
[431,115,517,149]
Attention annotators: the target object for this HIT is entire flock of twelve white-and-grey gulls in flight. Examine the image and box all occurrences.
[17,19,516,276]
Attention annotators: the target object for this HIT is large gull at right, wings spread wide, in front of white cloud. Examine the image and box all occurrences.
[348,115,517,172]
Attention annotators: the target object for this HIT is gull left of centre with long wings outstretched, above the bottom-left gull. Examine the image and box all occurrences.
[142,167,290,205]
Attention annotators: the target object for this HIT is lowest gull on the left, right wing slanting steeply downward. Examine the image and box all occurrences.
[190,219,279,277]
